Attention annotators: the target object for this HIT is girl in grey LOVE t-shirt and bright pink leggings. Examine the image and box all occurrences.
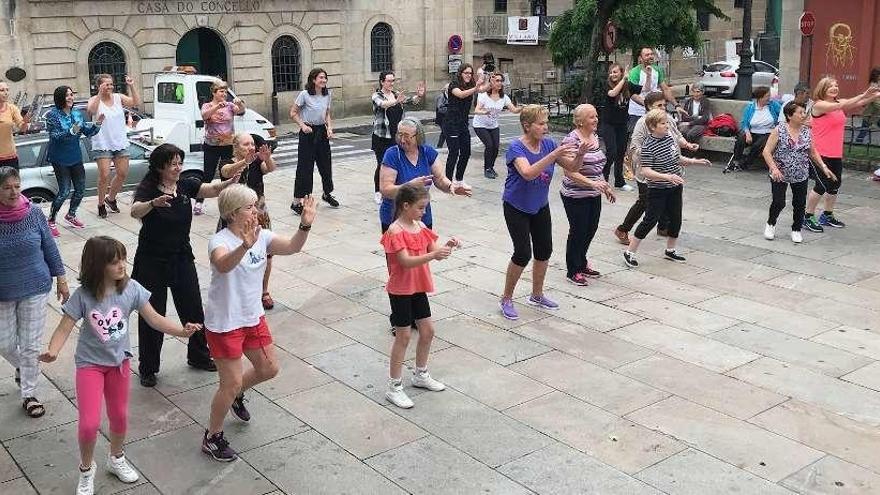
[40,236,201,495]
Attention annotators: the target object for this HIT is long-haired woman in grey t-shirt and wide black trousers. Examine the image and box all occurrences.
[290,67,339,215]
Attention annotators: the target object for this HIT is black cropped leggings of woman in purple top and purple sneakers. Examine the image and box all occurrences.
[504,201,553,267]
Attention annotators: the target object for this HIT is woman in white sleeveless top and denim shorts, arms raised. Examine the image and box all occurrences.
[86,74,140,218]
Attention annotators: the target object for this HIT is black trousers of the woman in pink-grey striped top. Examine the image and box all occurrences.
[560,194,602,278]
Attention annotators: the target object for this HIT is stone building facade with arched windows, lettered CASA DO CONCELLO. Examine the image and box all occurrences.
[0,0,472,122]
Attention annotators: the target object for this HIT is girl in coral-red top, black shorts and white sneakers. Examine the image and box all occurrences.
[380,183,459,409]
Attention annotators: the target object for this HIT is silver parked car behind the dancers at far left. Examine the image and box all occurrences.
[15,133,203,203]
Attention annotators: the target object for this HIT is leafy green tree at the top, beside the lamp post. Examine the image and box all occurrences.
[547,0,728,101]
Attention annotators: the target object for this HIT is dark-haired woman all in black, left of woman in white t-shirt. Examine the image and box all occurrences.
[443,64,489,187]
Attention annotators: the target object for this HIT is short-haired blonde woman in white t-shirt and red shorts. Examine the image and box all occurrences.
[202,184,316,462]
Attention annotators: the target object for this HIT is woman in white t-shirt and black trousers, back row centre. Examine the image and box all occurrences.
[473,72,520,179]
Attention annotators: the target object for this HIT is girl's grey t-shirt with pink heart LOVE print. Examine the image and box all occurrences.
[62,280,150,368]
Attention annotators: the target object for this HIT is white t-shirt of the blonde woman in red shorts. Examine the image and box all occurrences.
[205,228,275,333]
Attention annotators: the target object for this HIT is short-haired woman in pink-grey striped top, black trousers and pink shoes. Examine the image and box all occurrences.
[559,104,616,286]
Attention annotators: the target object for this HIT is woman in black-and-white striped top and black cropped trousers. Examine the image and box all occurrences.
[623,109,712,268]
